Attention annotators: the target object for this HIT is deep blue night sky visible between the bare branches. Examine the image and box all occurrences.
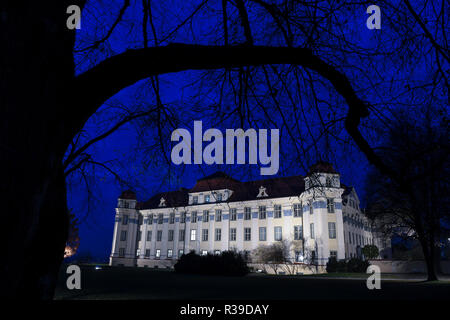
[68,0,445,259]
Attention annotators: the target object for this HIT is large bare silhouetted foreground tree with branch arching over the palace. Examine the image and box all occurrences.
[0,0,448,298]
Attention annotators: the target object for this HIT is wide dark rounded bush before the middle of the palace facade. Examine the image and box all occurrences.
[174,251,249,276]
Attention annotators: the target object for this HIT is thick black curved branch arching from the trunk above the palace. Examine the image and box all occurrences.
[72,44,395,177]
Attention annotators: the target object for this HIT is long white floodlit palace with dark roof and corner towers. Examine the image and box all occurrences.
[110,162,383,268]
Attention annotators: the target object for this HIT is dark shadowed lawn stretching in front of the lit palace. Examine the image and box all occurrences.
[55,265,450,300]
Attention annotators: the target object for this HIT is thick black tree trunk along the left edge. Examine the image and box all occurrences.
[0,0,81,299]
